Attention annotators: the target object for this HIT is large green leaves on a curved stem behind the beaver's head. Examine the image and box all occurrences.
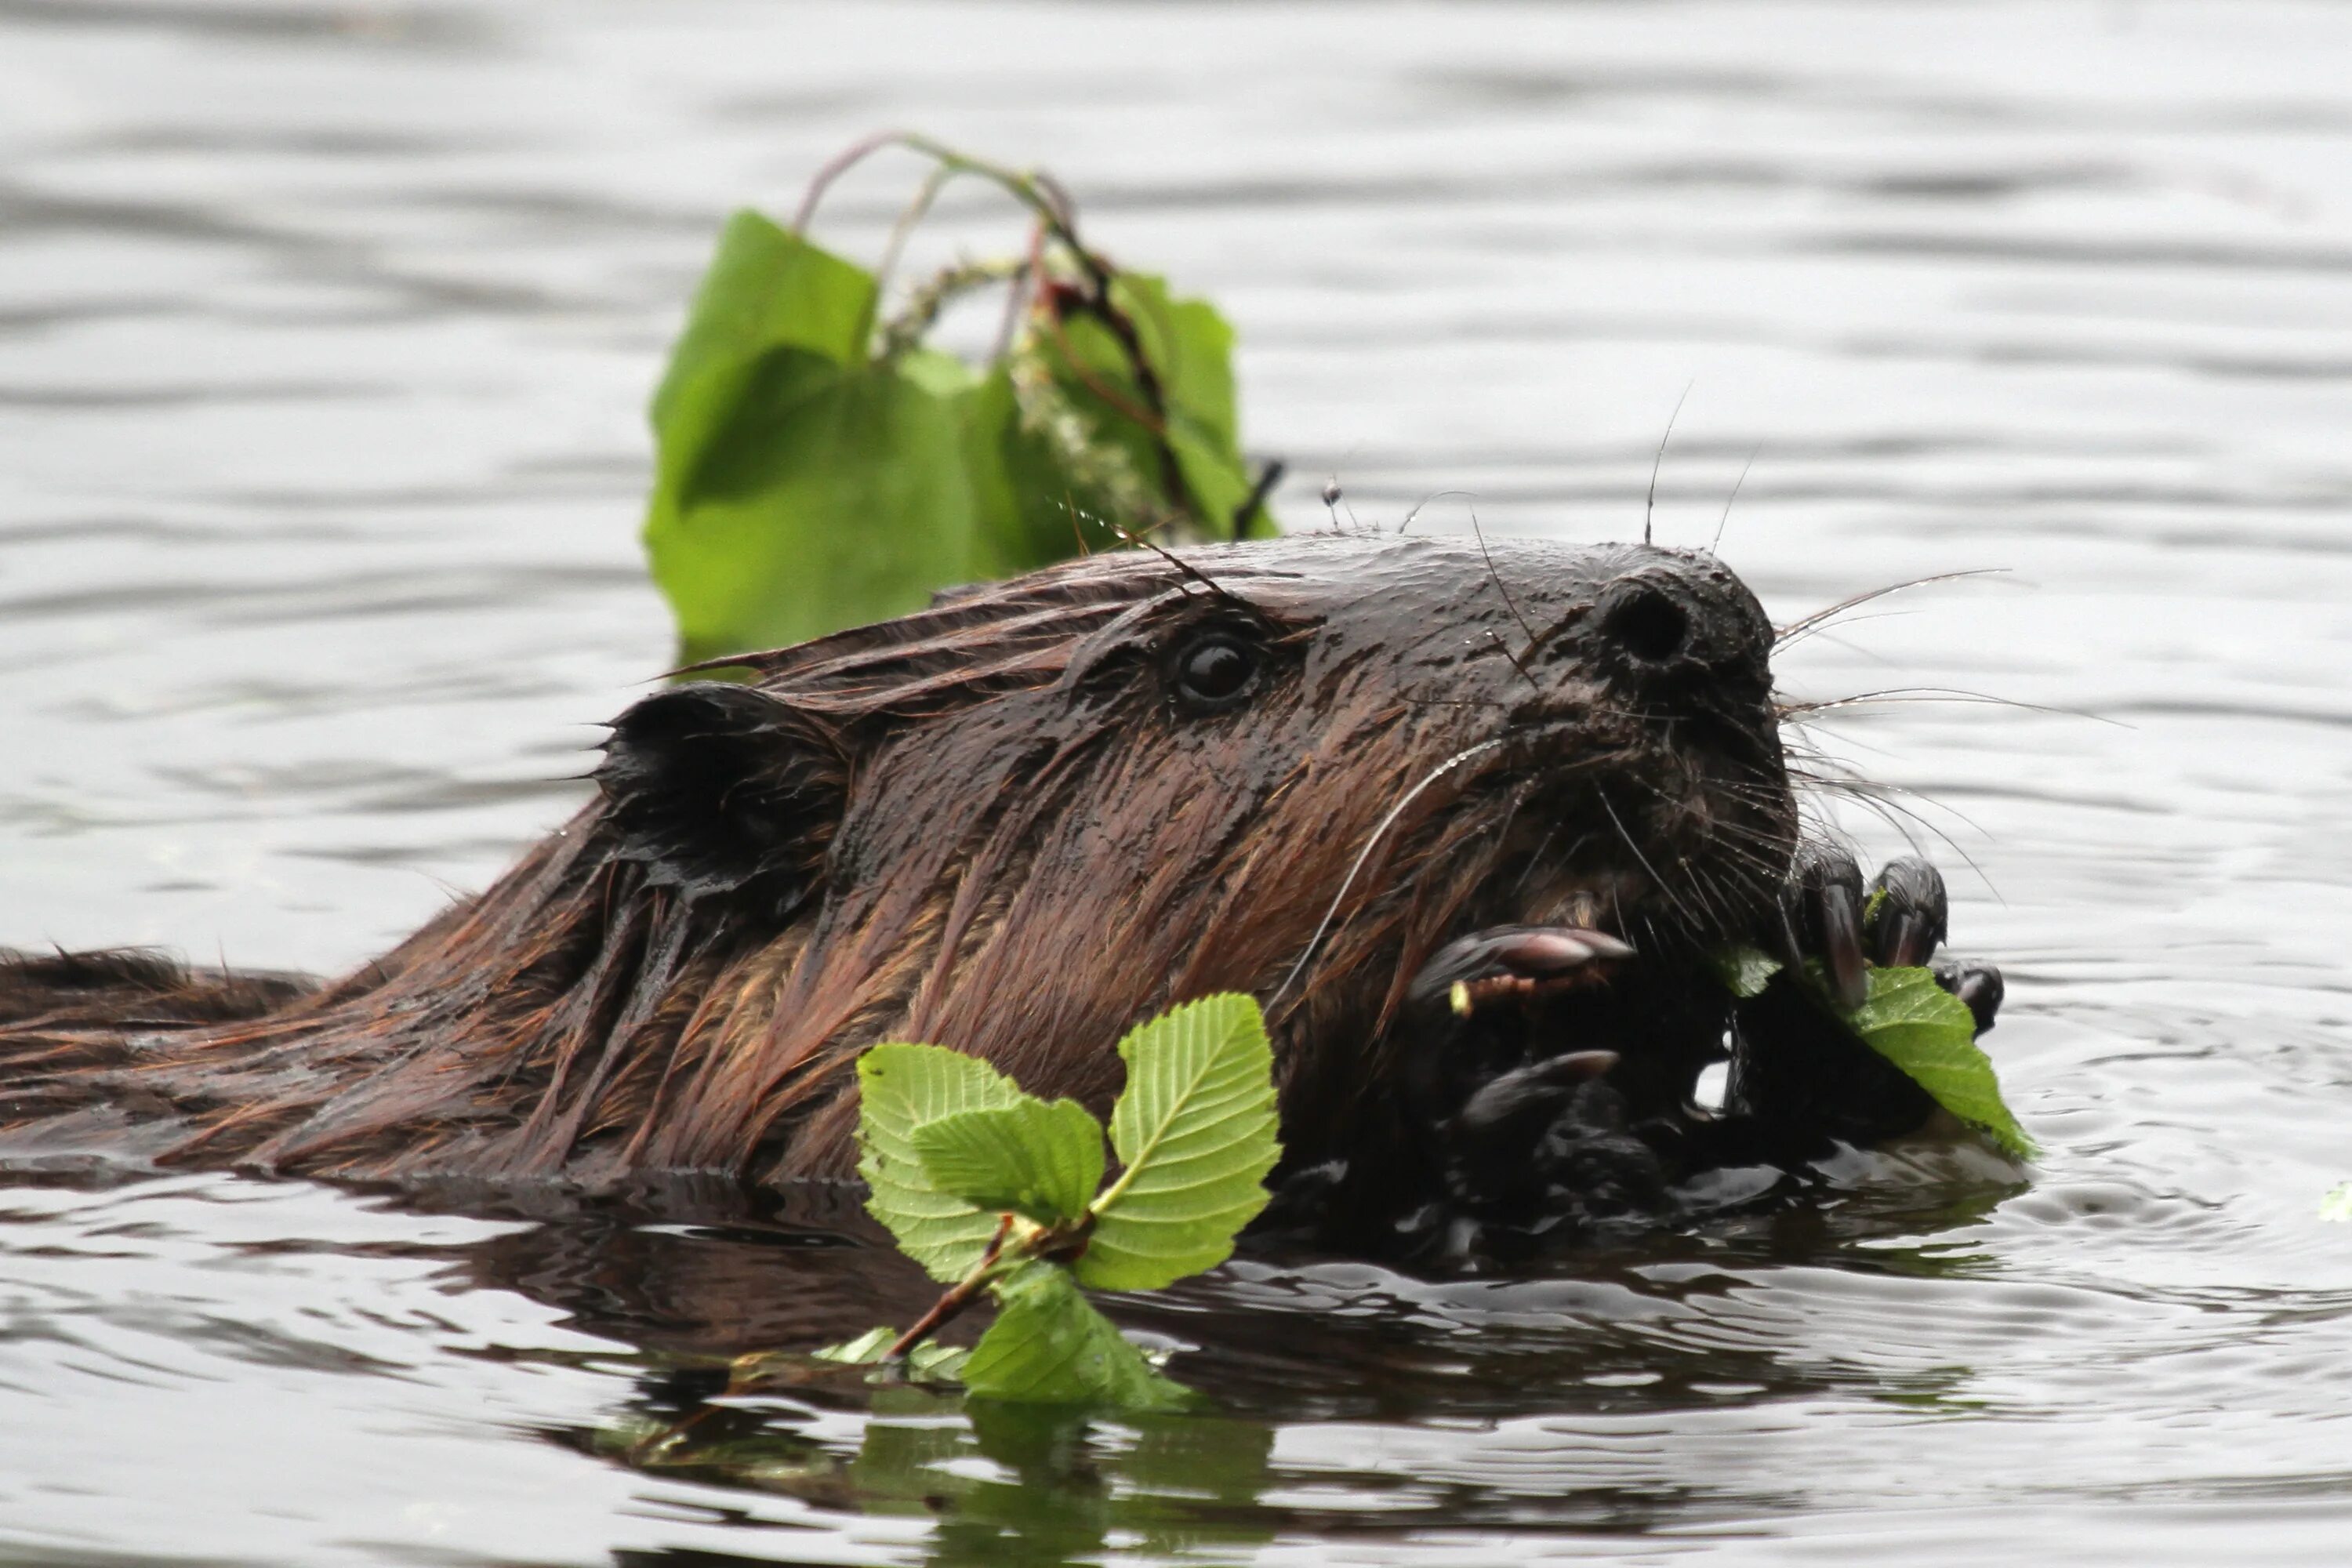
[644,132,1279,661]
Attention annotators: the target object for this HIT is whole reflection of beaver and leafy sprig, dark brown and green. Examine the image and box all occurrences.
[435,1173,2002,1563]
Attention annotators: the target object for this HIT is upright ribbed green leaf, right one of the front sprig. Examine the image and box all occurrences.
[1077,994,1282,1290]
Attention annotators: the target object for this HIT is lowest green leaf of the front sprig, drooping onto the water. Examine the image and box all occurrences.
[964,1262,1192,1410]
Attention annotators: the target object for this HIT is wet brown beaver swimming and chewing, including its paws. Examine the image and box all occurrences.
[0,536,1999,1258]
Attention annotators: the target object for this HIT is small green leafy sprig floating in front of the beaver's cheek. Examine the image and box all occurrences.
[828,994,1282,1410]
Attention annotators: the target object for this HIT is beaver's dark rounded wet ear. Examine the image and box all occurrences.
[595,682,849,914]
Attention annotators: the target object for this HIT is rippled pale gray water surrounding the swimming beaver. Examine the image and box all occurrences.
[0,0,2352,1568]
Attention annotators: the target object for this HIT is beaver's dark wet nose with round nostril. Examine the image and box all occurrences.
[1592,550,1771,684]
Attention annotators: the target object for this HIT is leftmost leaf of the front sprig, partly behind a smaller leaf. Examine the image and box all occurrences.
[858,1044,1035,1281]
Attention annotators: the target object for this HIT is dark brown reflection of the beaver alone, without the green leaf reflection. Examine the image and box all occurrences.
[445,1178,2009,1420]
